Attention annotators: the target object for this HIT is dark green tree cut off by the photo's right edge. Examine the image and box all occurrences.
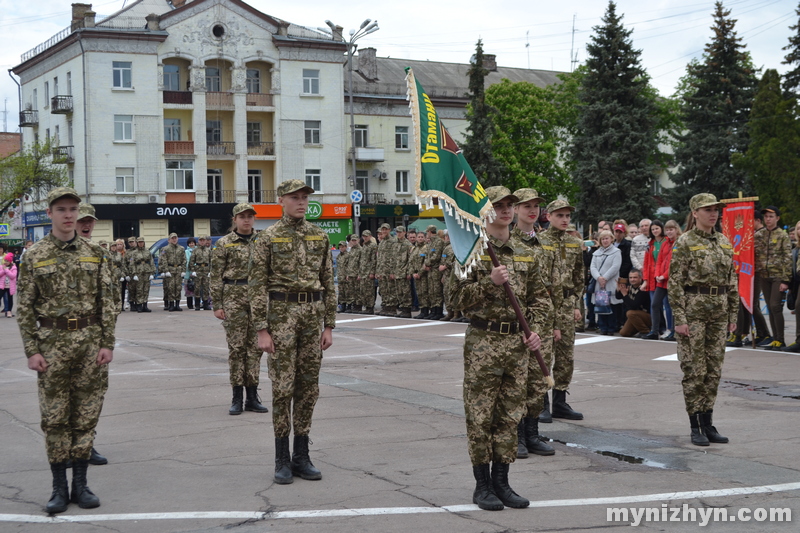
[733,69,800,225]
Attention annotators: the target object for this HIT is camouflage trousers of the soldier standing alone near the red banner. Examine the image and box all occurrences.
[675,294,728,415]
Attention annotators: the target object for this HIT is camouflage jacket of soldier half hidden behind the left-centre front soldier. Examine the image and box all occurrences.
[209,231,258,311]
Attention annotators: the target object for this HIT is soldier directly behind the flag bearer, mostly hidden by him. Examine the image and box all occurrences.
[512,189,561,458]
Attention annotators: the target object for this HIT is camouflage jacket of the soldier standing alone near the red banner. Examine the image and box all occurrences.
[667,229,739,326]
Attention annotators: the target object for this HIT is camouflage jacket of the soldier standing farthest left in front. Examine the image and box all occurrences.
[17,233,117,357]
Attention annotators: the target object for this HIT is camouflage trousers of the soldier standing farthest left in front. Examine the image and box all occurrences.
[38,325,108,463]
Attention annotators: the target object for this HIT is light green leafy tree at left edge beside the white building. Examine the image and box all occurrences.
[0,139,68,216]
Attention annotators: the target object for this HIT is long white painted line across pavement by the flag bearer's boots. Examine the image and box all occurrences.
[6,482,800,524]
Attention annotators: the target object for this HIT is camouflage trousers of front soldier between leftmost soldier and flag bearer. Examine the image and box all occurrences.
[268,300,322,438]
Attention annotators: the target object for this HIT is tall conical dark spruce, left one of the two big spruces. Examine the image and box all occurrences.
[571,1,658,222]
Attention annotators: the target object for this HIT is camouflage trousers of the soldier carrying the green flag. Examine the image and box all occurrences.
[464,327,528,465]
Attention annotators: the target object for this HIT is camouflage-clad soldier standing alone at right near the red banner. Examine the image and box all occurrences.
[667,193,739,446]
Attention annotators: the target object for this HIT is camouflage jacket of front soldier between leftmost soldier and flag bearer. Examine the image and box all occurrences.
[250,215,336,331]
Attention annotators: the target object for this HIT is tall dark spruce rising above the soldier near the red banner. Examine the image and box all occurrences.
[667,1,757,215]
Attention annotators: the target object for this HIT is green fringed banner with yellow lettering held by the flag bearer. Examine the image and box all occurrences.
[406,68,494,276]
